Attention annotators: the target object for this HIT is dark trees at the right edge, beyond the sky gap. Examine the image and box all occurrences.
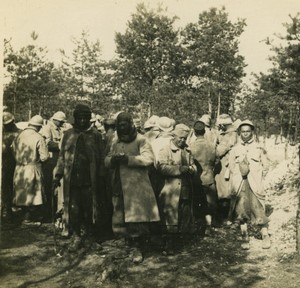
[237,13,300,143]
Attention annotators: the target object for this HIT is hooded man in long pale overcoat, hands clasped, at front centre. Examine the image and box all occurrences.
[105,112,160,262]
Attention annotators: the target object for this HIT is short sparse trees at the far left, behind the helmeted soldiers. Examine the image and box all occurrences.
[4,32,64,121]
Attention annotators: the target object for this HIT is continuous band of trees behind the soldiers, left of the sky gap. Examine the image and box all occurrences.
[4,4,245,124]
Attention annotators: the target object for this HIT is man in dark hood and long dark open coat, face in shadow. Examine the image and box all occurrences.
[53,104,104,250]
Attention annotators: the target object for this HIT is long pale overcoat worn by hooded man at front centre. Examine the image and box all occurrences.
[105,134,160,223]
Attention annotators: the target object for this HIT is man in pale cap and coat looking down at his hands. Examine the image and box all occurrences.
[157,124,197,253]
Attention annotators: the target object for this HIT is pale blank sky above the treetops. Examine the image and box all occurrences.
[0,0,300,83]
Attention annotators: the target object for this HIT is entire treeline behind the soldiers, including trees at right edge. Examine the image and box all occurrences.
[4,4,300,141]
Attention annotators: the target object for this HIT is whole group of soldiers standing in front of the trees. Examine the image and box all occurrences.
[1,104,271,263]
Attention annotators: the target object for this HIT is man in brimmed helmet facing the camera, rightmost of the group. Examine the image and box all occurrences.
[229,120,270,249]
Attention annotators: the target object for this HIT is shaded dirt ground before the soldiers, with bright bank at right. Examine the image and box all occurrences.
[0,143,300,288]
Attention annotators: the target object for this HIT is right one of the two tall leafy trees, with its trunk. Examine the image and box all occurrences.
[182,8,246,116]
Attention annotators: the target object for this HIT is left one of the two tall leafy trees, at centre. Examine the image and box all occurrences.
[115,4,183,116]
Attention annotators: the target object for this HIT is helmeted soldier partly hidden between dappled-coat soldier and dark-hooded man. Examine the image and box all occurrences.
[40,111,66,221]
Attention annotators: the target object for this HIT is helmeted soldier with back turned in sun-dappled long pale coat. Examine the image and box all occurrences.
[12,115,49,224]
